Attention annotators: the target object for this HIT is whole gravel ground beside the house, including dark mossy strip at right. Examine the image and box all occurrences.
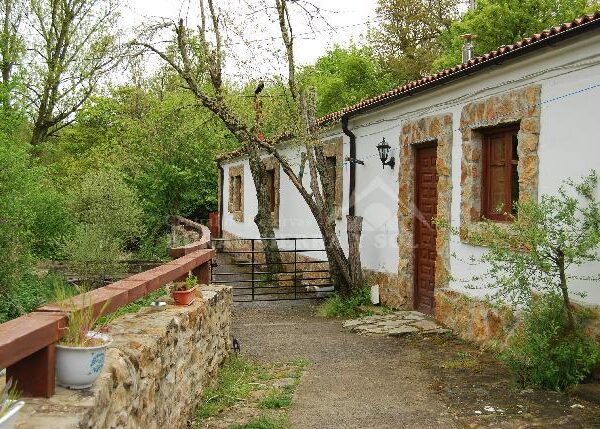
[233,301,600,429]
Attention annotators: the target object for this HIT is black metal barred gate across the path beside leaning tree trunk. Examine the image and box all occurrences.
[212,237,334,302]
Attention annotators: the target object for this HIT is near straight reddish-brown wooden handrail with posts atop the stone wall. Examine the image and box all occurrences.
[0,242,214,397]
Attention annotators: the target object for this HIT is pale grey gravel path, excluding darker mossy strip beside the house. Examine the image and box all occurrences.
[233,302,456,429]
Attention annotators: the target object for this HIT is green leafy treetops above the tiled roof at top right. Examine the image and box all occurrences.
[434,0,600,69]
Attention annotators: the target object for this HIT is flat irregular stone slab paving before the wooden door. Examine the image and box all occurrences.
[343,311,450,336]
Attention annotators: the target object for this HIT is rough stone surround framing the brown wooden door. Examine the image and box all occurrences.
[395,113,453,309]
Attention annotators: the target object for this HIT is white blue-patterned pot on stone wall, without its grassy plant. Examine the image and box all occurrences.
[56,331,112,389]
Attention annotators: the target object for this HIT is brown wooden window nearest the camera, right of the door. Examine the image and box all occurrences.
[481,127,519,221]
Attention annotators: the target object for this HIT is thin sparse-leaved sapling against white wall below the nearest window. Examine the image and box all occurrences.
[462,172,600,332]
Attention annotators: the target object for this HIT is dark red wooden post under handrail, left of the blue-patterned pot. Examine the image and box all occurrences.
[6,344,56,398]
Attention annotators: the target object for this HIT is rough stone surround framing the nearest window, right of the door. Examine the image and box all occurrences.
[460,85,542,245]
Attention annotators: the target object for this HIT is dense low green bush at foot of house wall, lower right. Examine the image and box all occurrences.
[500,294,600,390]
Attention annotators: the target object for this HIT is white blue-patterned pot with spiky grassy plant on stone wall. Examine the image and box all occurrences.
[56,286,112,389]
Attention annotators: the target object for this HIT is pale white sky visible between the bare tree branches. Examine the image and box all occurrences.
[122,0,377,81]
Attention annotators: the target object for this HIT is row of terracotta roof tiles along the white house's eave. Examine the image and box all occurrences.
[317,10,600,125]
